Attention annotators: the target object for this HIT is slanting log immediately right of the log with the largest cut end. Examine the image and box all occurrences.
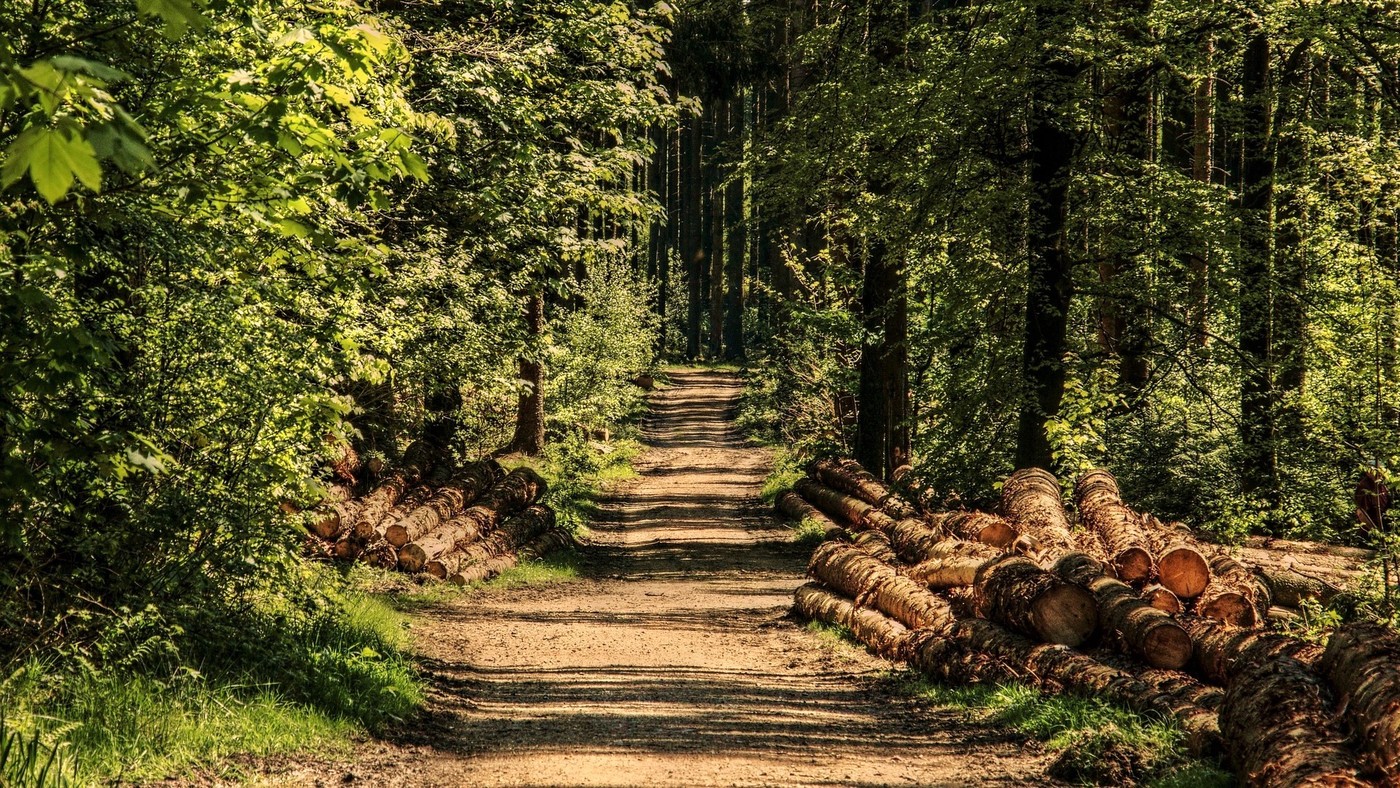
[1056,553,1191,670]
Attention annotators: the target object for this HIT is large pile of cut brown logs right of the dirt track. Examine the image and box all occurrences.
[777,460,1400,785]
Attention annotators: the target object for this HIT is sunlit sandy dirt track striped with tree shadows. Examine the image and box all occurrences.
[267,371,1047,787]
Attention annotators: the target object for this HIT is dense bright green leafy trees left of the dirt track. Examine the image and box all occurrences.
[0,0,673,655]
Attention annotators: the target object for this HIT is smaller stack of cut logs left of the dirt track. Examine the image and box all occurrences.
[308,444,573,585]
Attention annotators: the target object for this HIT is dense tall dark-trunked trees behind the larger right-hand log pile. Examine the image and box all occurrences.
[648,0,1400,548]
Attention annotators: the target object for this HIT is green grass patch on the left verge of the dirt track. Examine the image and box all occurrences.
[0,570,423,785]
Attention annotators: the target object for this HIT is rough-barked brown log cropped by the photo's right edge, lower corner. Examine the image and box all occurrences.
[1317,621,1400,785]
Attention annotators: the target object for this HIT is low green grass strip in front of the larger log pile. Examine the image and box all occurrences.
[896,675,1235,788]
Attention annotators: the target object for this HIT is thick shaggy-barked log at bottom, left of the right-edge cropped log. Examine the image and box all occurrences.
[1219,655,1375,788]
